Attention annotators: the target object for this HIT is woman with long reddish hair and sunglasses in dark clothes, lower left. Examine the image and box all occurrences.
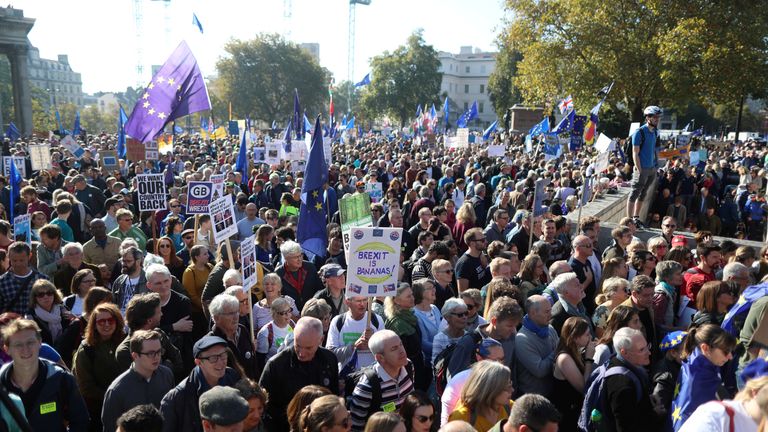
[72,303,125,432]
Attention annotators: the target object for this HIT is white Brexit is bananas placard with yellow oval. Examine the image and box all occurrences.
[346,227,403,297]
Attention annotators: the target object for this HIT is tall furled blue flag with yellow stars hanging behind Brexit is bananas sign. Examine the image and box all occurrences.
[296,116,328,260]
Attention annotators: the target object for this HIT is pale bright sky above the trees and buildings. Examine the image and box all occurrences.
[12,0,504,93]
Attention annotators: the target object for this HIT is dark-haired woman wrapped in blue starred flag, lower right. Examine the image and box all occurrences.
[671,324,737,430]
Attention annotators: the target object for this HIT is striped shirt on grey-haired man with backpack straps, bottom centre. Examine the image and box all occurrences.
[349,360,413,431]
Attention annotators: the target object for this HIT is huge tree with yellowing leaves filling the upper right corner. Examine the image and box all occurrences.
[505,0,768,120]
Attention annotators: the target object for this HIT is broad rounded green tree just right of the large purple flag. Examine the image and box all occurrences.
[214,34,330,122]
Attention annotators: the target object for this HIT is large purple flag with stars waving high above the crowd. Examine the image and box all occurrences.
[125,41,211,142]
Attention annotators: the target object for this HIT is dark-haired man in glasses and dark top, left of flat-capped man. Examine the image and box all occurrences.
[101,330,175,432]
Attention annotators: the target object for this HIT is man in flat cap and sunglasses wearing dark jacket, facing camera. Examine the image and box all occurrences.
[160,335,240,431]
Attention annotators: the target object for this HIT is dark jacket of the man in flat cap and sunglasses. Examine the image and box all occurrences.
[160,367,240,432]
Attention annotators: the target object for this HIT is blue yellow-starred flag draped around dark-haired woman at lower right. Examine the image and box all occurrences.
[671,348,722,431]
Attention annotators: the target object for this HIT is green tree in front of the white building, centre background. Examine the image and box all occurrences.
[362,30,442,126]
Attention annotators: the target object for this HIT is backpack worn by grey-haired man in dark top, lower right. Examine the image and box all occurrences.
[578,364,642,432]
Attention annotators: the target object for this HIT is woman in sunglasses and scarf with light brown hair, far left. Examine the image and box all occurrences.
[26,279,74,345]
